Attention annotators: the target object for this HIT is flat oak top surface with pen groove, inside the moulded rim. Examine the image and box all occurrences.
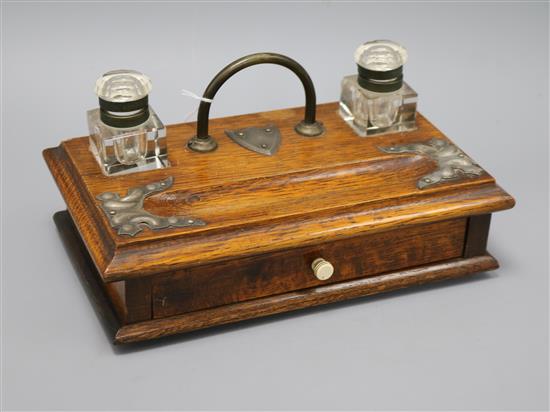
[57,103,492,244]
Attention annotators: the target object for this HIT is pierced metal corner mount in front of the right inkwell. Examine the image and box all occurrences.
[379,137,483,189]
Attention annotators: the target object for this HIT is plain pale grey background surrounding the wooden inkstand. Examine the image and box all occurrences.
[2,2,548,410]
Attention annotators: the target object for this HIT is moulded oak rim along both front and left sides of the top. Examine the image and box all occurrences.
[44,120,515,282]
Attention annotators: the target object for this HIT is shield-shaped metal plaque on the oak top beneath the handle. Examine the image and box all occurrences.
[225,124,281,156]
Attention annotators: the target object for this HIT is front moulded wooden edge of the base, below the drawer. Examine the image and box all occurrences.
[118,254,498,344]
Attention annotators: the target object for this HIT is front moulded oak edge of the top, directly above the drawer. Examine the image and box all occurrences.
[102,184,514,281]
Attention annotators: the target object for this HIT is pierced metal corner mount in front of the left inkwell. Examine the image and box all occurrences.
[97,176,206,236]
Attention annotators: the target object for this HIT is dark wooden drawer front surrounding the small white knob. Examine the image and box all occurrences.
[152,218,467,318]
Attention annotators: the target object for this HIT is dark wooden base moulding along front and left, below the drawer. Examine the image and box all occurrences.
[54,211,498,344]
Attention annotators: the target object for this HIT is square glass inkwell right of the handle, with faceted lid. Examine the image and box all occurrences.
[340,40,418,137]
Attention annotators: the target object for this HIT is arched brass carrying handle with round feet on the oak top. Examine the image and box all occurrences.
[187,53,324,153]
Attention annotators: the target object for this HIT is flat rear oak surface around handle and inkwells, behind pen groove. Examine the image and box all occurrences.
[63,103,484,186]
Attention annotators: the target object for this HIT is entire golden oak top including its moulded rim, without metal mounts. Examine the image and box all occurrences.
[44,103,514,282]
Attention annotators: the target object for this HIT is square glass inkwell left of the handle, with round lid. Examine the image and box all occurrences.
[88,70,169,176]
